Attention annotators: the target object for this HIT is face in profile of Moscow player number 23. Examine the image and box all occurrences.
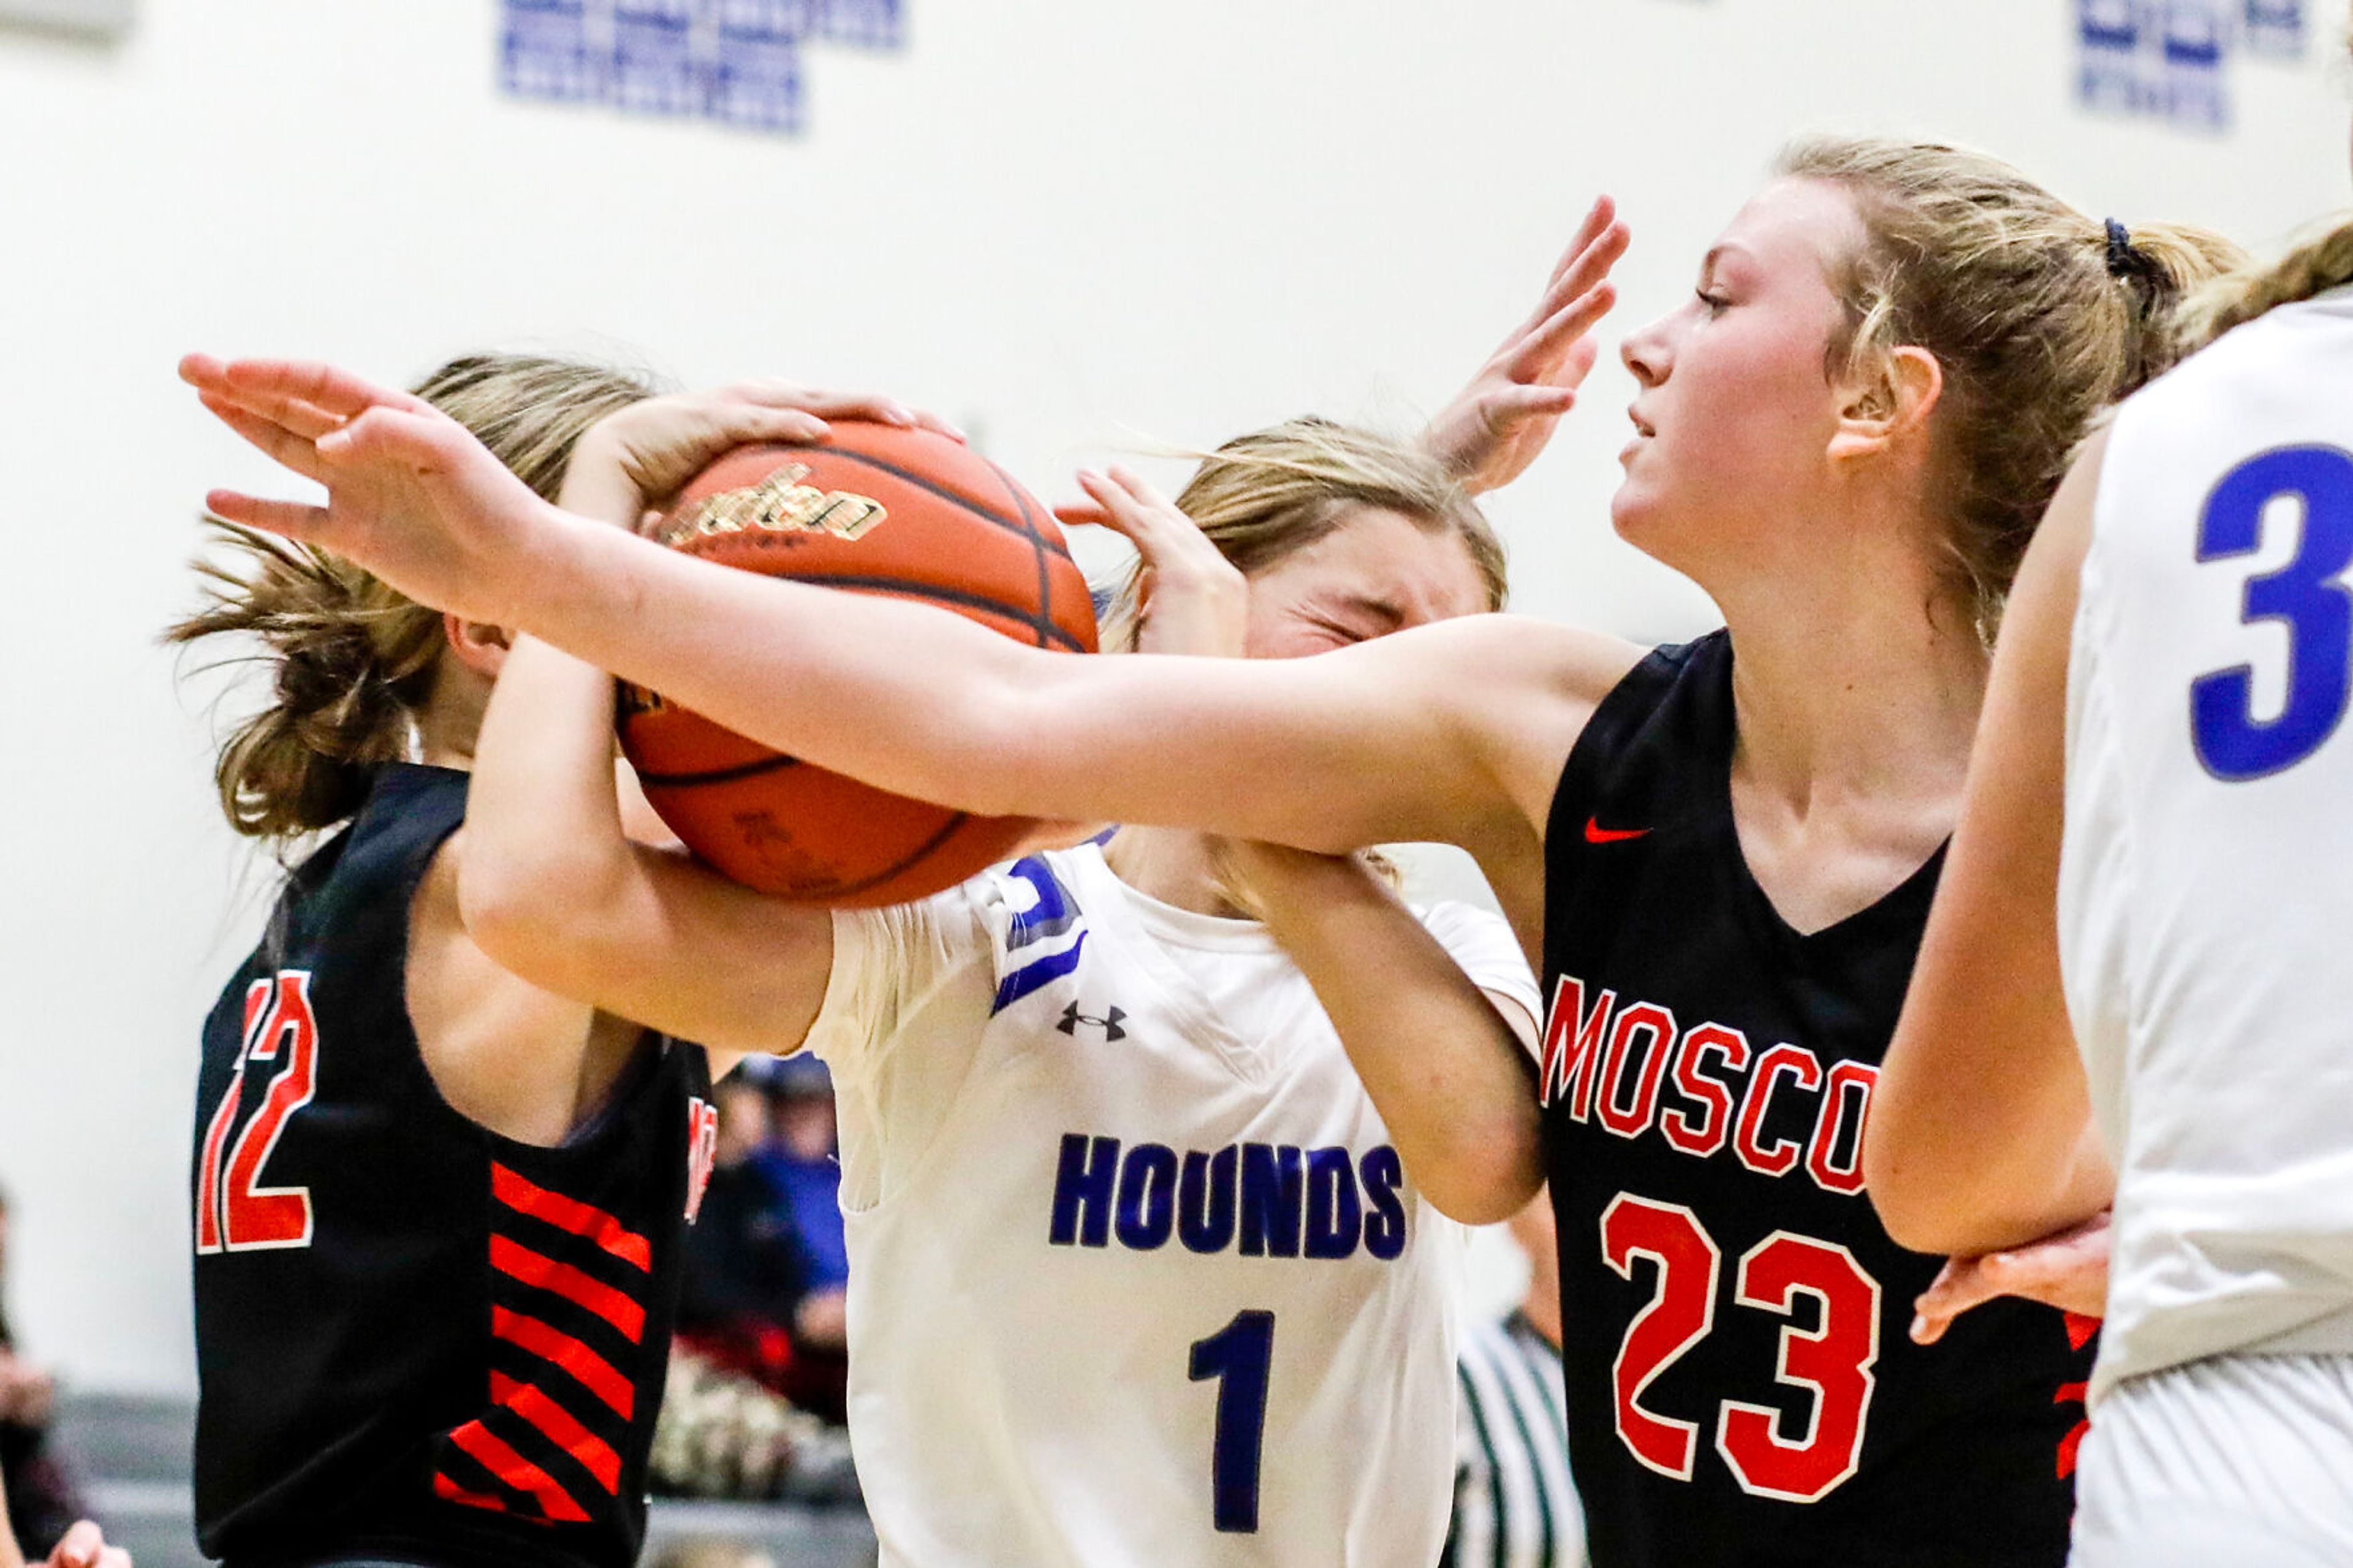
[1610,179,1866,584]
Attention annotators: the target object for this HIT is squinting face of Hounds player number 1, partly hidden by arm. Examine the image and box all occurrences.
[1243,506,1487,659]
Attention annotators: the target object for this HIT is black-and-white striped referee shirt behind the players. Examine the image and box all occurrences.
[1440,1311,1586,1568]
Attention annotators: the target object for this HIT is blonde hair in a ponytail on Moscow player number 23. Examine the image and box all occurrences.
[1779,137,2243,621]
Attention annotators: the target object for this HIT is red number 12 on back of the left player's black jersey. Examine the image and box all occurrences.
[195,970,317,1255]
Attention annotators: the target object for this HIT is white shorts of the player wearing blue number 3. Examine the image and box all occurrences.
[2068,1356,2353,1568]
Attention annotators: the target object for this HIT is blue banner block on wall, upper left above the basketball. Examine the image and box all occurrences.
[499,0,906,134]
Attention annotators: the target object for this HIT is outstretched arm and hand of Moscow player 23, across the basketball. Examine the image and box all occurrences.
[188,360,1633,852]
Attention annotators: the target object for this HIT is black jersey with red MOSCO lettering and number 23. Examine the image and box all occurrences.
[1541,634,2092,1568]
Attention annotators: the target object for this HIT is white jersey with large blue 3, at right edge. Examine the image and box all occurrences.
[2059,290,2353,1401]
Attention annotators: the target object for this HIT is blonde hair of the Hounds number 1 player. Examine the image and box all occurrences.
[1101,417,1506,652]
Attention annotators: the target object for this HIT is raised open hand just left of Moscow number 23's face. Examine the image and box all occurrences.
[1421,195,1628,492]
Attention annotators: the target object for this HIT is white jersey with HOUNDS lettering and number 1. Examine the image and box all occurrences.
[812,845,1537,1568]
